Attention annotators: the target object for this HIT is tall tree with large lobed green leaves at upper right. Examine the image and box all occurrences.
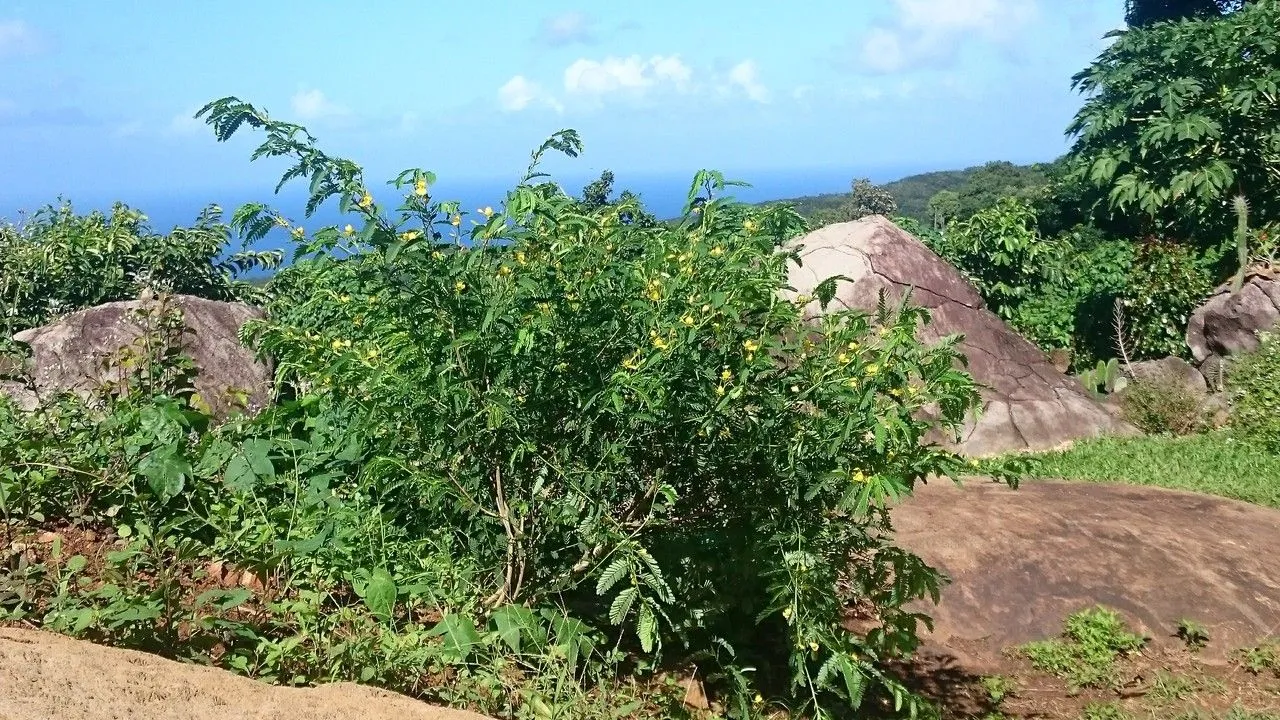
[1068,0,1280,241]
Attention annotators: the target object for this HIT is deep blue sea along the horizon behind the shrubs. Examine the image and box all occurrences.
[0,167,936,278]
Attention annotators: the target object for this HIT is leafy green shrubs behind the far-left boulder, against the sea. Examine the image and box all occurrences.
[0,196,282,337]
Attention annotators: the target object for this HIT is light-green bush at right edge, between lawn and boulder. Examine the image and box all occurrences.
[1226,331,1280,452]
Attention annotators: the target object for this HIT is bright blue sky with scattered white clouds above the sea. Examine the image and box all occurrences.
[0,0,1123,215]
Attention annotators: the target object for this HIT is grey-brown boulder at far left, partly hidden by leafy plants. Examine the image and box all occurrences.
[0,289,271,419]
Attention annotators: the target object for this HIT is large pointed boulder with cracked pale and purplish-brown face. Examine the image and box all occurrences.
[788,215,1137,456]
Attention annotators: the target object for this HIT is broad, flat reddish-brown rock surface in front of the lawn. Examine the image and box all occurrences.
[893,480,1280,670]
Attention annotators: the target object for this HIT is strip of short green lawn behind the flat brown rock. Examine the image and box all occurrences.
[993,432,1280,509]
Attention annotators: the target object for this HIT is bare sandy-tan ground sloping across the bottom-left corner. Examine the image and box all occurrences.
[0,629,485,720]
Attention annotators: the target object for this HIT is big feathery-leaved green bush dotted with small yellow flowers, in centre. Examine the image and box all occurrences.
[189,97,978,717]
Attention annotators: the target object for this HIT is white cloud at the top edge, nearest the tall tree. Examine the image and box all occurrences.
[859,0,1038,73]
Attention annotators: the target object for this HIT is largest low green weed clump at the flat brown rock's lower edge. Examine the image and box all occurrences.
[1018,606,1146,691]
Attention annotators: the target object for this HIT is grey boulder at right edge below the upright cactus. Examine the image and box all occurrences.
[1187,274,1280,363]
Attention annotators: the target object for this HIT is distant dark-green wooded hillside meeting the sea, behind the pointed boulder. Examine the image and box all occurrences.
[769,160,1059,223]
